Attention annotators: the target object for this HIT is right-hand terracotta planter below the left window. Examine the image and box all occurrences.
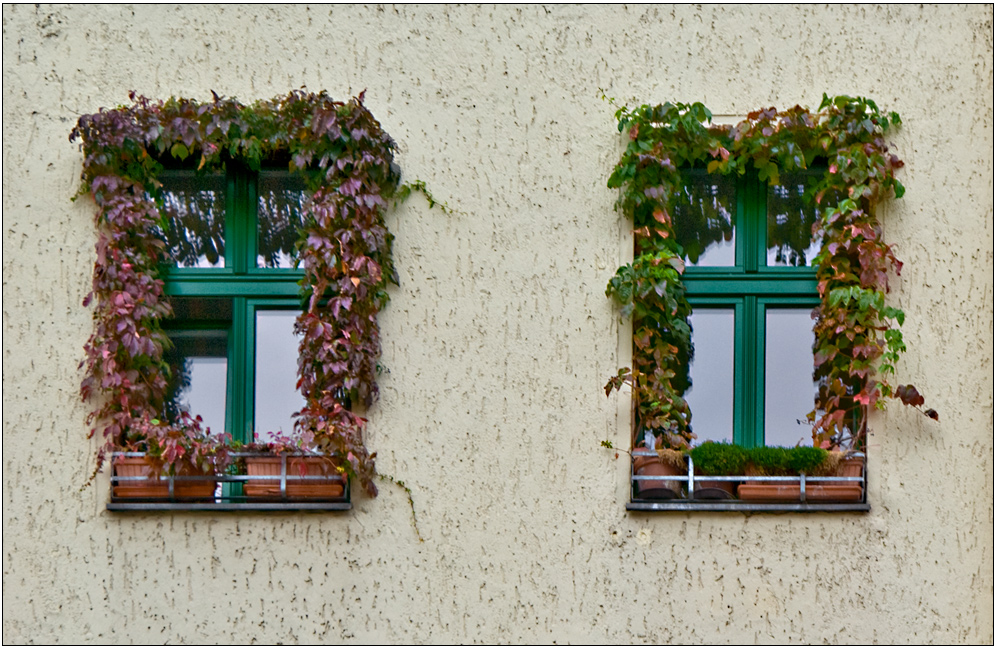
[243,456,346,499]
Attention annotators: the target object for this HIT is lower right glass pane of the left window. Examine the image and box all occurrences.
[253,309,305,442]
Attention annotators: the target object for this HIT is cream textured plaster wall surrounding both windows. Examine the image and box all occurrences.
[3,5,994,643]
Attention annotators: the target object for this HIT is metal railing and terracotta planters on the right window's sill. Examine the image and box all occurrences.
[627,449,869,512]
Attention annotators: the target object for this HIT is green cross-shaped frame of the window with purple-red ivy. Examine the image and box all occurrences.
[159,162,305,443]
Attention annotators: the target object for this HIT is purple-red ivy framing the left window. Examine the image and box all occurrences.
[70,90,425,496]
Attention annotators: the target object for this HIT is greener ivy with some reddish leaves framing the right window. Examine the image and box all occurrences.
[606,95,938,449]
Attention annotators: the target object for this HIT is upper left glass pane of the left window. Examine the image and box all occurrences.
[160,172,226,268]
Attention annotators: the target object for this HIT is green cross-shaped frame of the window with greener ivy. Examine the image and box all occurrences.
[677,170,820,447]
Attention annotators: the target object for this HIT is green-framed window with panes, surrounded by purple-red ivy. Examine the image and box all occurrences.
[159,164,305,442]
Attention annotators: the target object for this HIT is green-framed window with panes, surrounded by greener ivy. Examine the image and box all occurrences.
[674,170,820,446]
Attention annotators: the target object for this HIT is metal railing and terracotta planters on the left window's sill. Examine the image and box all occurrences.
[107,452,352,511]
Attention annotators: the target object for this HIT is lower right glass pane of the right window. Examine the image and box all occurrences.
[765,307,817,447]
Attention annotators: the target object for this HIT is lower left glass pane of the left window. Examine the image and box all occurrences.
[163,330,228,433]
